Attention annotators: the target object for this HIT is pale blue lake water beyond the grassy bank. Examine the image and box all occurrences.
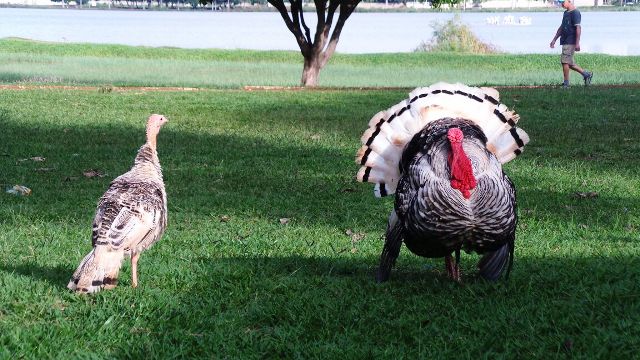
[0,8,640,55]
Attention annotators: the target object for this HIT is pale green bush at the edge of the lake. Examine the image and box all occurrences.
[415,15,498,54]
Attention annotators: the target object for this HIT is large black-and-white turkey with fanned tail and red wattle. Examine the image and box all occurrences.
[356,83,529,282]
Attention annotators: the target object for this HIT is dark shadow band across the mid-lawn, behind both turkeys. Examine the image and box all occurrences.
[0,104,640,232]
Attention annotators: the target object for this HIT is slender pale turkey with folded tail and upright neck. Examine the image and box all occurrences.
[67,114,167,293]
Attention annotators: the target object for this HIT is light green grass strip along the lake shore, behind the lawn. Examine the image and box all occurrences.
[0,39,640,88]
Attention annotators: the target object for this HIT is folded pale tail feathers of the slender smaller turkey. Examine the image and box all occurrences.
[67,248,124,293]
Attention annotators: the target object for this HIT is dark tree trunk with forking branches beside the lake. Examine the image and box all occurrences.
[267,0,460,86]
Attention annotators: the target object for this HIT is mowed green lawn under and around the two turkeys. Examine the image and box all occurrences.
[0,87,640,359]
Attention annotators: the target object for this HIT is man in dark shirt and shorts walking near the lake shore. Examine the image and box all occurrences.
[550,0,593,89]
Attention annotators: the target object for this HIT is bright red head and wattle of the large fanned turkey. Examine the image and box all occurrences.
[447,128,476,199]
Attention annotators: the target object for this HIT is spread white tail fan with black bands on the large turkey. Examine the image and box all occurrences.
[356,83,529,197]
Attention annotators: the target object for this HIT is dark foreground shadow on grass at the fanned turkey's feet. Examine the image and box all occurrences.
[100,256,640,358]
